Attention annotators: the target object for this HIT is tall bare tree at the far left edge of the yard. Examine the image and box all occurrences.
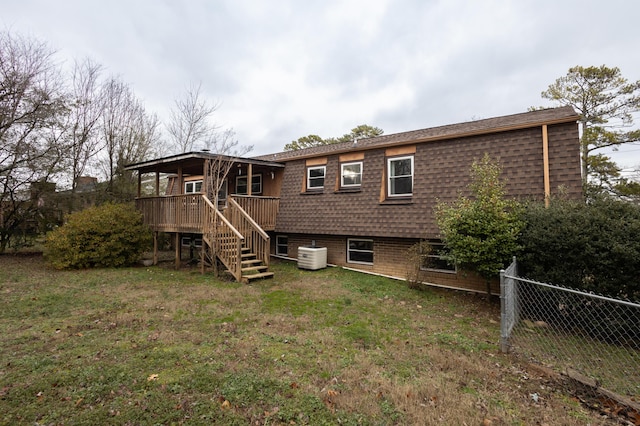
[0,32,67,252]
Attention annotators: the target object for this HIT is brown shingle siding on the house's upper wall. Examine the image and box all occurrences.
[276,122,581,238]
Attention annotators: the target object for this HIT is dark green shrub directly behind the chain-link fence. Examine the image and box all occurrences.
[519,198,640,300]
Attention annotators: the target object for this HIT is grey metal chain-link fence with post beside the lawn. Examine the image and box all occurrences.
[500,258,640,401]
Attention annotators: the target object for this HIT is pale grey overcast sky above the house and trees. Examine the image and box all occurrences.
[0,0,640,173]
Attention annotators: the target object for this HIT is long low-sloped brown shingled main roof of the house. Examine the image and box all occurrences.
[254,106,580,162]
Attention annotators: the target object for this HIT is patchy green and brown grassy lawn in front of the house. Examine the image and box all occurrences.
[0,256,609,425]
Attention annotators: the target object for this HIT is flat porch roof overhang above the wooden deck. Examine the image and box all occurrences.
[124,151,285,175]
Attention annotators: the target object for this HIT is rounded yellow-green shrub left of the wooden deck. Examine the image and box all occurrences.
[44,204,151,269]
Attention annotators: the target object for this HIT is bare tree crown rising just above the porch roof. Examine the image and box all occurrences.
[167,84,218,152]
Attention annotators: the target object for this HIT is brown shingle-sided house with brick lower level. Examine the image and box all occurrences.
[128,107,582,292]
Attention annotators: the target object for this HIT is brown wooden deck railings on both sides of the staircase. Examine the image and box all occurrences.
[136,194,280,234]
